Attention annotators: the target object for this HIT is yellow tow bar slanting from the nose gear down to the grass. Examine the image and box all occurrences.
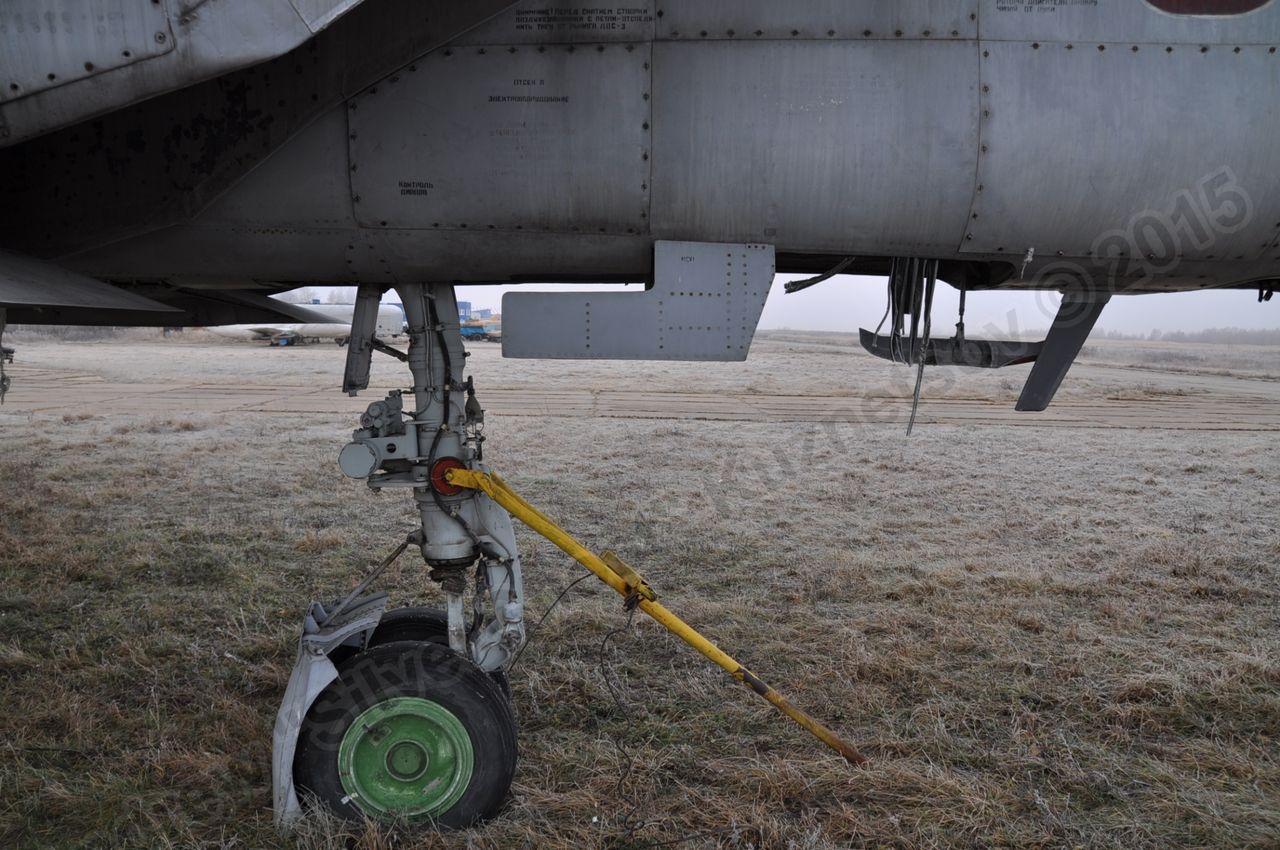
[445,469,867,764]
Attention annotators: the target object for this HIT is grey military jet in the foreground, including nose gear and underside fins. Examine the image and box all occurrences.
[0,0,1280,826]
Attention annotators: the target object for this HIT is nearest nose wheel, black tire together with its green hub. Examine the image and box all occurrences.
[293,641,516,828]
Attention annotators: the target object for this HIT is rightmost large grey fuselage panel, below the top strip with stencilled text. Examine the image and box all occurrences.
[960,42,1280,262]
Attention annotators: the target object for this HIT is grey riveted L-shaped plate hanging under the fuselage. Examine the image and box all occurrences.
[502,242,774,360]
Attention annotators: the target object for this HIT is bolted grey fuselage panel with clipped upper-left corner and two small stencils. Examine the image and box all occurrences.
[348,45,650,233]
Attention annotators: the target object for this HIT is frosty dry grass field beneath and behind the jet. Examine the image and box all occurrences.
[0,333,1280,850]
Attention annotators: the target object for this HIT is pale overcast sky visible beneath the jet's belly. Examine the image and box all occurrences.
[458,275,1280,337]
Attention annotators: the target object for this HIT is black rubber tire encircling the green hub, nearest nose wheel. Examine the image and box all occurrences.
[293,641,516,828]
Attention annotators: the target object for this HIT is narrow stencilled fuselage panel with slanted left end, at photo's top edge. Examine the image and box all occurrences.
[453,0,654,46]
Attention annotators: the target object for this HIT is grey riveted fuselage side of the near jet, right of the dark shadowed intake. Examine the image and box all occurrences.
[15,0,1280,291]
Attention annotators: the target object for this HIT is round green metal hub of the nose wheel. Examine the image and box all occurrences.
[338,696,475,818]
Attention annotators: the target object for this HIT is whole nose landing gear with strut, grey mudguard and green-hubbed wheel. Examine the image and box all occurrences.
[273,284,525,827]
